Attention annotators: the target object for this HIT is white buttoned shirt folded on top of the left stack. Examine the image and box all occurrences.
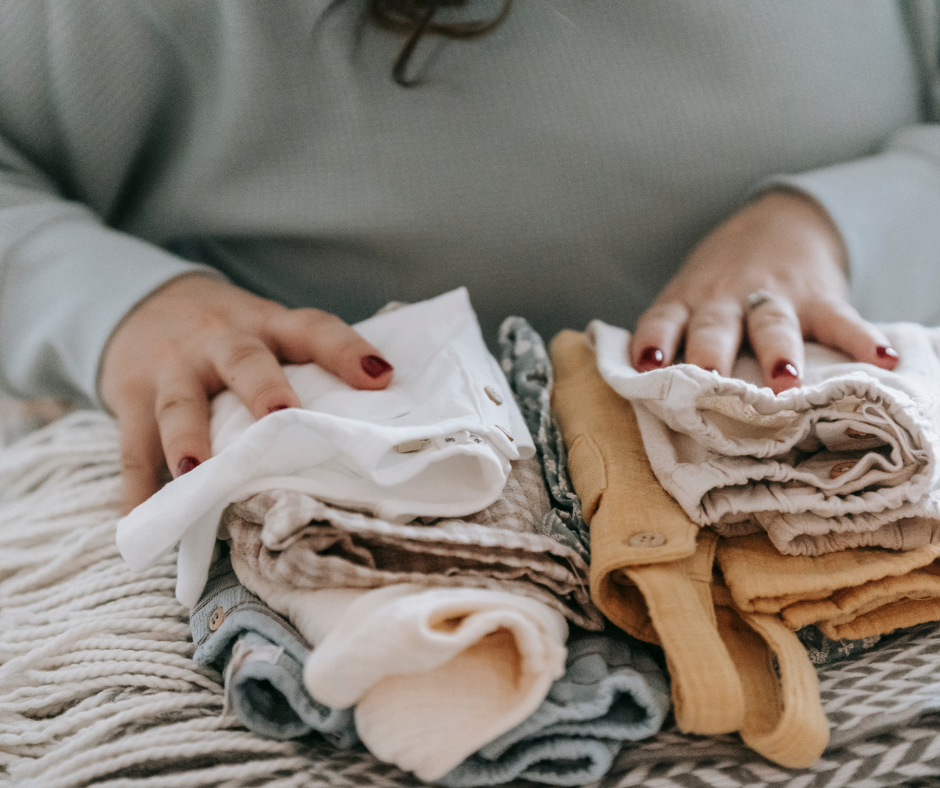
[117,288,535,606]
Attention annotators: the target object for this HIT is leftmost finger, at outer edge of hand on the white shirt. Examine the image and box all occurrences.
[117,397,163,514]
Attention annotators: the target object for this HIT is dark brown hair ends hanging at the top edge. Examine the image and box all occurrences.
[369,0,512,88]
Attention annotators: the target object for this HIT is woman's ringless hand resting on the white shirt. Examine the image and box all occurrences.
[101,274,392,512]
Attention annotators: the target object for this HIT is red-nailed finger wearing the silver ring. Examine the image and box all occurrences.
[745,298,805,394]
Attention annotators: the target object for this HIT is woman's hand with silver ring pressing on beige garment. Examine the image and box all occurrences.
[630,191,898,393]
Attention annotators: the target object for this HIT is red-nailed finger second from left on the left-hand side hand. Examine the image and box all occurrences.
[154,374,212,479]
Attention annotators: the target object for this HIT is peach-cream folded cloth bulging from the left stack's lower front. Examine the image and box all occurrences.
[227,561,568,781]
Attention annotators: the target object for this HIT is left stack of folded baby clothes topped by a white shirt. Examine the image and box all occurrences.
[118,290,669,786]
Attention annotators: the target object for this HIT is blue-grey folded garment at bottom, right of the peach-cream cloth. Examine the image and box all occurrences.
[438,634,669,788]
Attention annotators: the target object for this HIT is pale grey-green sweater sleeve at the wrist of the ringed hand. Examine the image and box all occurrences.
[763,124,940,325]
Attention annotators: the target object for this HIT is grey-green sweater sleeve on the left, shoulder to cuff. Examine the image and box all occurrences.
[0,0,217,404]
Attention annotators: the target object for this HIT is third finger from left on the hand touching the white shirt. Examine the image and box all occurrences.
[208,333,300,419]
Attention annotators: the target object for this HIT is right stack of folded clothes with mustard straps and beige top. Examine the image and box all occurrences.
[552,323,940,767]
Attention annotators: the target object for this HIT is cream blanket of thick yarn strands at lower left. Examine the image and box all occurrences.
[0,412,430,788]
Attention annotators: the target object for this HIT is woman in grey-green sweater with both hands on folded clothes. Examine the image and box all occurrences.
[0,0,940,507]
